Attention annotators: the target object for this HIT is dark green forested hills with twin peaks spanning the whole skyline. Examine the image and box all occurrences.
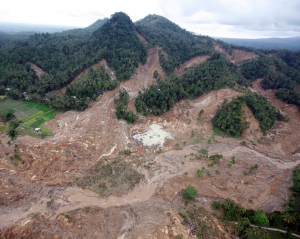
[0,12,300,114]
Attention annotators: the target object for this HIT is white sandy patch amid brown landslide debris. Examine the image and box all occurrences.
[133,124,174,146]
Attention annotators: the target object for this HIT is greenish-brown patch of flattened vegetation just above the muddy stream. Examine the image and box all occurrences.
[74,156,143,197]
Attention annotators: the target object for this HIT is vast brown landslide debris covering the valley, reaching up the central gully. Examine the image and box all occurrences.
[0,51,300,239]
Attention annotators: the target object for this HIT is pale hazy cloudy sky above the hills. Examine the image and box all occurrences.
[0,0,300,38]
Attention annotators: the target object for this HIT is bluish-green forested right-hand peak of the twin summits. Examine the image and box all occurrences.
[136,15,212,73]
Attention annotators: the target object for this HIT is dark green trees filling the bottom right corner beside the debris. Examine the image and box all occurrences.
[212,185,300,239]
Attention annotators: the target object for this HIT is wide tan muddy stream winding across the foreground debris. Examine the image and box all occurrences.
[0,147,205,228]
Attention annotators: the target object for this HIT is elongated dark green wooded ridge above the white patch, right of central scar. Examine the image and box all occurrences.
[135,53,237,115]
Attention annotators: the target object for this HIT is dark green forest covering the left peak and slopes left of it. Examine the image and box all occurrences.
[0,13,147,110]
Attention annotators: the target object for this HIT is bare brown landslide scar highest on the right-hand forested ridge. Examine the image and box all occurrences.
[213,42,258,65]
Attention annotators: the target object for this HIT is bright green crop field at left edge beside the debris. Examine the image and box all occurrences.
[0,99,55,136]
